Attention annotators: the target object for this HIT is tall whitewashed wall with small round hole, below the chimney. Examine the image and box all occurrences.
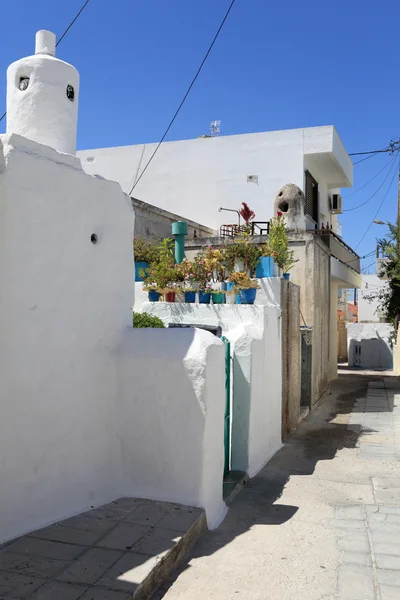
[0,135,134,541]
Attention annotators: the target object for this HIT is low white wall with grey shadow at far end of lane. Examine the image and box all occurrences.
[347,323,394,369]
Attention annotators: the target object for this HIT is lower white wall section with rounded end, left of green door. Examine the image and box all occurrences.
[117,329,226,529]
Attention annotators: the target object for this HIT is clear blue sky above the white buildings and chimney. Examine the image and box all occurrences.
[0,0,400,265]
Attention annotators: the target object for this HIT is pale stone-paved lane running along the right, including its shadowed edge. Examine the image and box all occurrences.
[158,371,400,600]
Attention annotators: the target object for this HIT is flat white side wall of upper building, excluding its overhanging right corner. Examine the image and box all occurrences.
[78,129,304,229]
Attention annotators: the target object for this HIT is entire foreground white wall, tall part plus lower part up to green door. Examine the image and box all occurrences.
[0,135,224,543]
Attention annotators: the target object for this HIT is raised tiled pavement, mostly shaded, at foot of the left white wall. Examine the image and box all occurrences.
[0,498,207,600]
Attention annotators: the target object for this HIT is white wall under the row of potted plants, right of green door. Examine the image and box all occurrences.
[142,302,282,477]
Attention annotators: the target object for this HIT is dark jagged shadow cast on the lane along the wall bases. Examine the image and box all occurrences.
[156,376,373,600]
